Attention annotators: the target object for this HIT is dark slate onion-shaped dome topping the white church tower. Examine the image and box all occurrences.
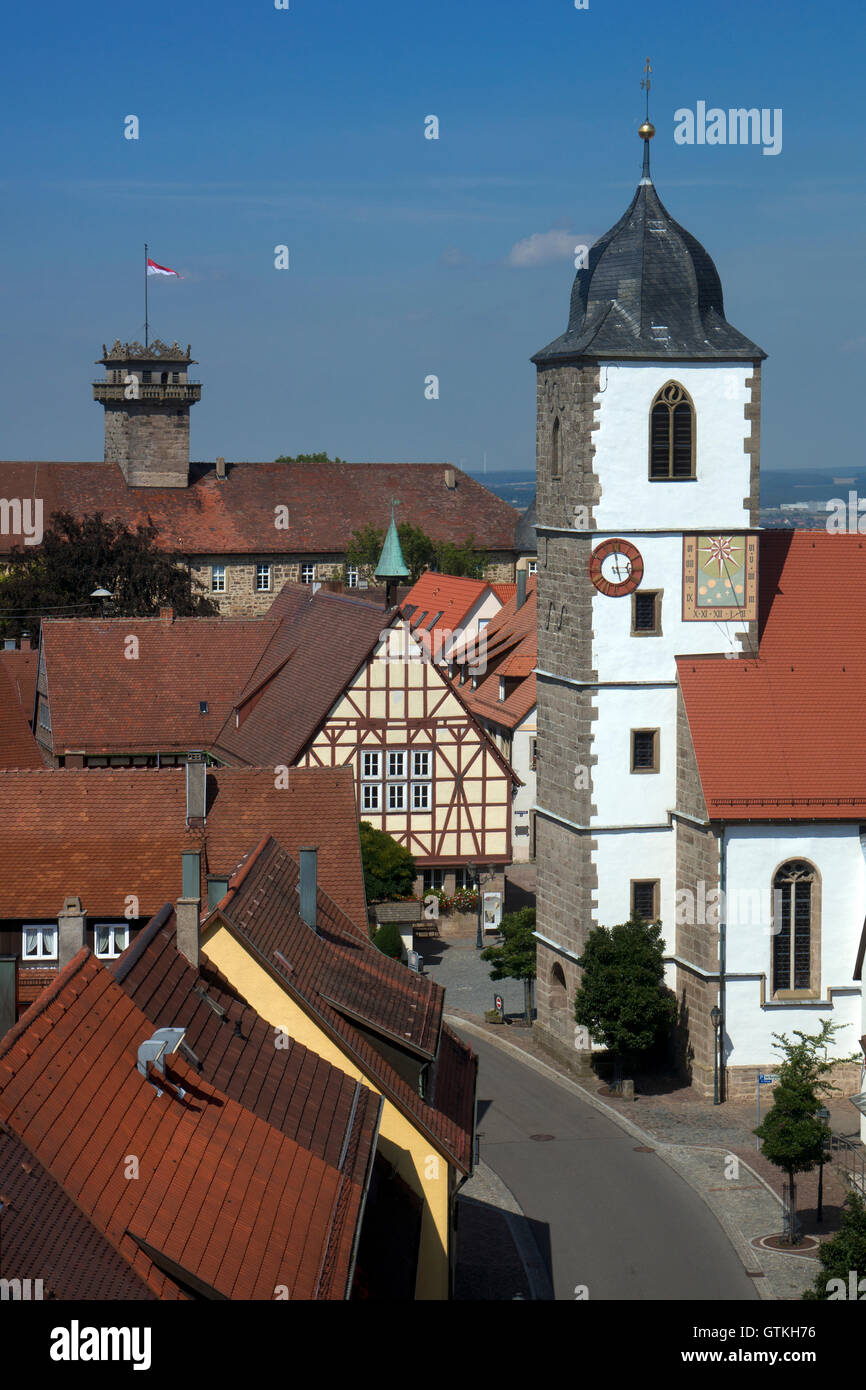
[532,122,766,366]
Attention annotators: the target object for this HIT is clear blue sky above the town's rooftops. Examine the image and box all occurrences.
[0,0,866,471]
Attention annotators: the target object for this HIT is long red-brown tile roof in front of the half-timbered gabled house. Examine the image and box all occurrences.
[0,767,367,935]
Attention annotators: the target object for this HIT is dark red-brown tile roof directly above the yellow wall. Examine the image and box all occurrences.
[211,838,477,1173]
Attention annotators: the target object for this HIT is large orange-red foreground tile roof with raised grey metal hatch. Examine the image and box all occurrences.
[0,951,361,1300]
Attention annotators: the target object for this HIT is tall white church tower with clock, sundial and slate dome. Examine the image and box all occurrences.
[532,121,766,1086]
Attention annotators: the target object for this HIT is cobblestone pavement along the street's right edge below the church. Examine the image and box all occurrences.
[446,1023,858,1300]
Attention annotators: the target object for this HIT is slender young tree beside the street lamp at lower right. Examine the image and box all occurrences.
[753,1019,856,1241]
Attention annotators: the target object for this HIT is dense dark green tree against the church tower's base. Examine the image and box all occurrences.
[574,916,677,1087]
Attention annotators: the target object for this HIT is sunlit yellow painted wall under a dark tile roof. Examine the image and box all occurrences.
[202,923,449,1300]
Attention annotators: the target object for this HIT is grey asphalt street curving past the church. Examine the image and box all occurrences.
[455,1023,756,1300]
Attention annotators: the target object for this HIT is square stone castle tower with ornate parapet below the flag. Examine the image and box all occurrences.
[93,338,202,488]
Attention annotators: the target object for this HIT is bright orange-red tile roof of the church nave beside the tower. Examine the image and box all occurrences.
[677,531,866,820]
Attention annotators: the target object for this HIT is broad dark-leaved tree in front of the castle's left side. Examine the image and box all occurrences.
[0,512,220,635]
